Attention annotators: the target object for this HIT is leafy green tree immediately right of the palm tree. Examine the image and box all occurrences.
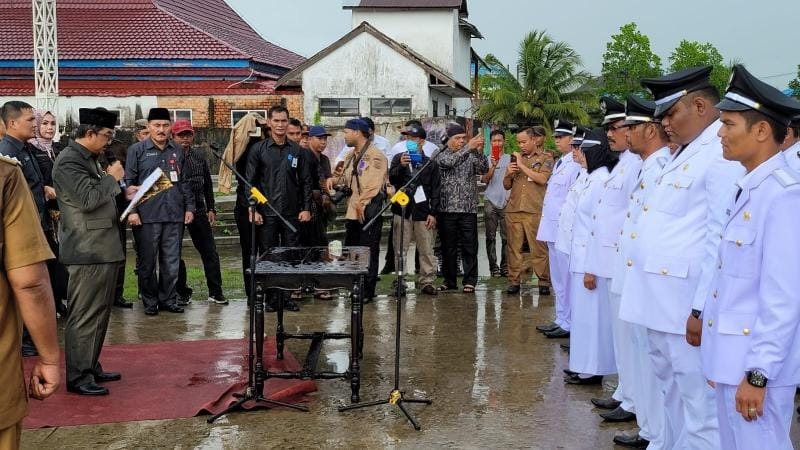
[601,22,661,99]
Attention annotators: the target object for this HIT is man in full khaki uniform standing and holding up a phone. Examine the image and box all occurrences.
[503,126,553,295]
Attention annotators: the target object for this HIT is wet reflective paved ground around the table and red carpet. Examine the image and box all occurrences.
[18,248,800,449]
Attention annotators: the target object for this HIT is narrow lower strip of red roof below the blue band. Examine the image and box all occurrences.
[0,80,275,97]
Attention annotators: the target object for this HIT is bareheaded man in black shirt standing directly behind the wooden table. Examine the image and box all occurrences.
[246,106,313,311]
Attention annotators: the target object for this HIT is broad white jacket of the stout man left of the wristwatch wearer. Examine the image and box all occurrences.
[622,121,744,334]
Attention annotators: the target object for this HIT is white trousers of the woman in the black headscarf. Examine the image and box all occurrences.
[569,272,617,375]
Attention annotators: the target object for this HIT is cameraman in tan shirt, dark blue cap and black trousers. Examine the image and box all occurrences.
[328,119,388,302]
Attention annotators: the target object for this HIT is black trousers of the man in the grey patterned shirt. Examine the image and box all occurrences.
[438,213,478,287]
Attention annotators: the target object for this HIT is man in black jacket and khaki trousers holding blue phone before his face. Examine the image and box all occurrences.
[389,126,441,295]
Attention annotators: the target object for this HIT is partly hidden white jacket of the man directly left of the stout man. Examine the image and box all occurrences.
[611,147,672,302]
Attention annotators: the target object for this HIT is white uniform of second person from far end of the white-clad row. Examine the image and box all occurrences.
[550,168,589,331]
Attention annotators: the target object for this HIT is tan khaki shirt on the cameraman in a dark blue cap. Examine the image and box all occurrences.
[342,144,389,220]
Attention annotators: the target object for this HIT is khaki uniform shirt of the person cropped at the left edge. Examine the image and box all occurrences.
[0,157,54,430]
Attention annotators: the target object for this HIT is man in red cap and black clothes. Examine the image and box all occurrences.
[172,120,228,305]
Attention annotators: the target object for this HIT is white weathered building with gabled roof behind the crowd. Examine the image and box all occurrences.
[276,0,481,126]
